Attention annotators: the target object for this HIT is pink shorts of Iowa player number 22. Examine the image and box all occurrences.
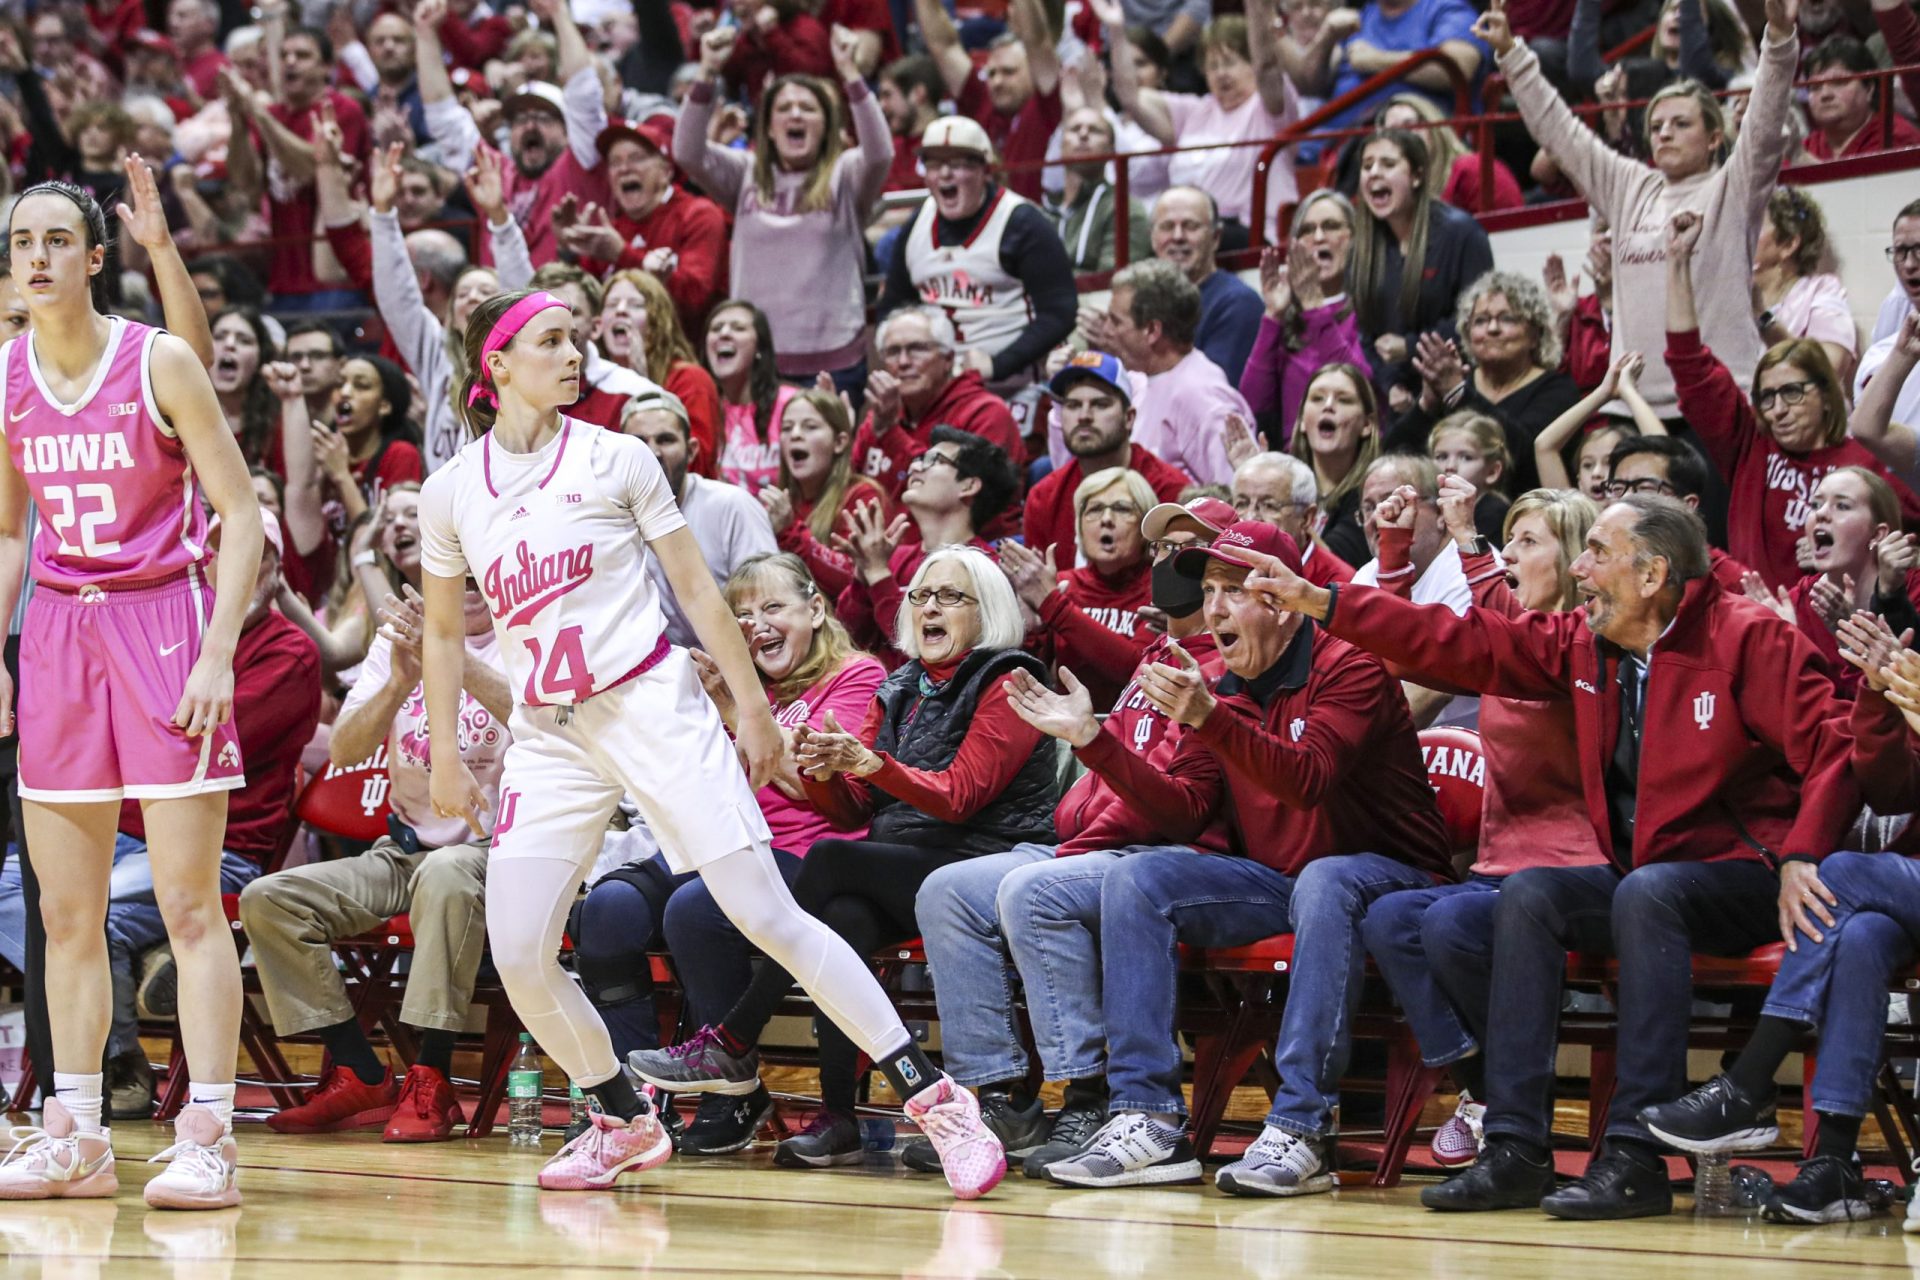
[17,570,246,804]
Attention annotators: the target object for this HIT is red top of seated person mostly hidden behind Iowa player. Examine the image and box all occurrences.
[119,610,321,862]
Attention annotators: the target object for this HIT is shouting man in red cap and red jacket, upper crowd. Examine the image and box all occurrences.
[561,115,728,342]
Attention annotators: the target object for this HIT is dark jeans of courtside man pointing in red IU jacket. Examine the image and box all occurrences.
[1486,862,1780,1148]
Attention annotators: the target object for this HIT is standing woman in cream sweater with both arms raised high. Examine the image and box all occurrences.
[1475,0,1799,418]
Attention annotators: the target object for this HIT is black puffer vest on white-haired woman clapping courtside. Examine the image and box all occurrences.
[868,649,1060,858]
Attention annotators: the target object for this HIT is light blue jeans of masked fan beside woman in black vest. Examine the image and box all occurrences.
[914,844,1190,1088]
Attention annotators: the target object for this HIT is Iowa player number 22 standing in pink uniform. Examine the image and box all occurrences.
[0,182,263,1209]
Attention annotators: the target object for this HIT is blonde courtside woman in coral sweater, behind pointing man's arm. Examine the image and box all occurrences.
[1361,476,1607,1167]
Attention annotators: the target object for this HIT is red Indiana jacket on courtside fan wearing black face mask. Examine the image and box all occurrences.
[1054,631,1229,858]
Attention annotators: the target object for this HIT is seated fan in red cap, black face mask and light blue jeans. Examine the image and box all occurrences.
[900,497,1231,1178]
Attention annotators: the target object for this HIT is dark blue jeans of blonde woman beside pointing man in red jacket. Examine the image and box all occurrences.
[1359,875,1500,1067]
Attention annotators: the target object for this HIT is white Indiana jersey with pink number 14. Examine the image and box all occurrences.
[420,418,687,706]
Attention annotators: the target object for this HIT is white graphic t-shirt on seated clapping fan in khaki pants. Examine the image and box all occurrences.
[340,631,513,848]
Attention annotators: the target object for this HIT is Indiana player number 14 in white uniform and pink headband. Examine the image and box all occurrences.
[420,292,1006,1199]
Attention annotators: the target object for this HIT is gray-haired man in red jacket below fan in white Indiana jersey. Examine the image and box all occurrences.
[852,307,1027,498]
